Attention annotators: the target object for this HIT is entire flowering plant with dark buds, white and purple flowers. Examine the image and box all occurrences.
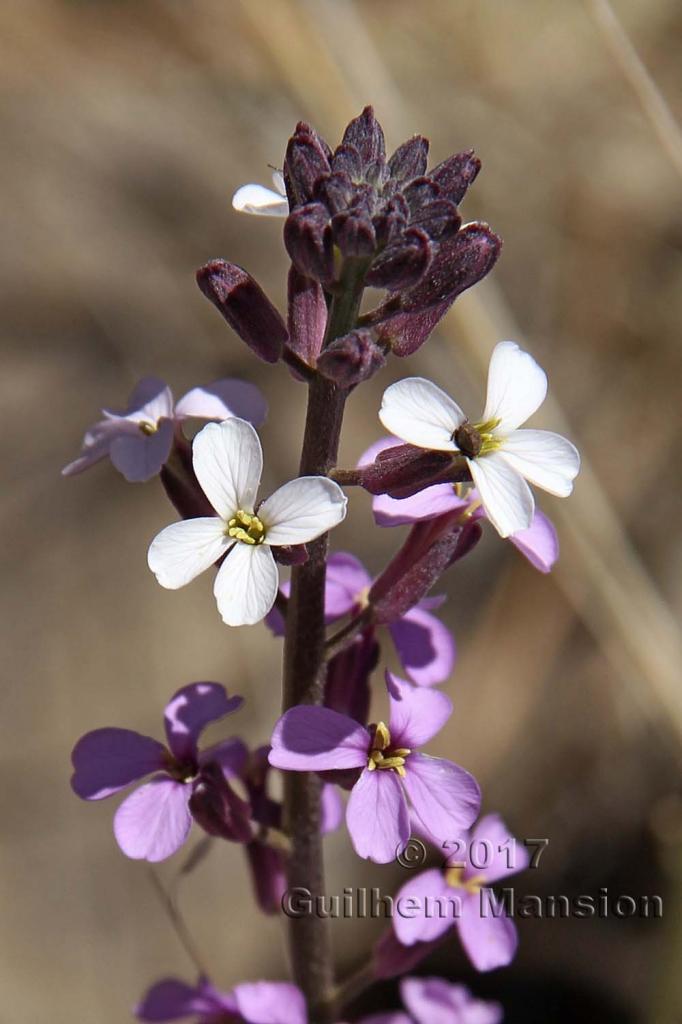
[65,106,579,1024]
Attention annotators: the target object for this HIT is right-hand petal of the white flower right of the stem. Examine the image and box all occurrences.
[500,430,581,498]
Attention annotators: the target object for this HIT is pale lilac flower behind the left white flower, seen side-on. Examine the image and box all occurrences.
[61,377,267,483]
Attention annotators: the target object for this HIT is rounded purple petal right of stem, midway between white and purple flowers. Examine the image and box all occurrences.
[389,605,456,686]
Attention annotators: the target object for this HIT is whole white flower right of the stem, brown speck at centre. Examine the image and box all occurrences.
[379,341,581,537]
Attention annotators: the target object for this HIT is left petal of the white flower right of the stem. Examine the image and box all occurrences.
[379,377,465,452]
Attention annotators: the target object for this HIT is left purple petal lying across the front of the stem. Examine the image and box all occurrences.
[268,705,370,771]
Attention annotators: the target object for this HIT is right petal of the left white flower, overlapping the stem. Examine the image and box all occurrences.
[258,476,347,547]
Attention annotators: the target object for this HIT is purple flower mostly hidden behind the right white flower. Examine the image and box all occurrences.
[358,437,559,572]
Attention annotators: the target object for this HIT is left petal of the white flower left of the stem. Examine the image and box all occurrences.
[146,516,228,590]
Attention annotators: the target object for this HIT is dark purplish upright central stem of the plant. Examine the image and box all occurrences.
[283,266,363,1024]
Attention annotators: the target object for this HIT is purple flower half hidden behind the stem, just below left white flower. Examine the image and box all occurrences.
[267,552,456,686]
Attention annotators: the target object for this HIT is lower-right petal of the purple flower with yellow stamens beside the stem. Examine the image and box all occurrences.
[402,753,480,842]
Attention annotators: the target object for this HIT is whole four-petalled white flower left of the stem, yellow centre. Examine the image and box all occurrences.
[147,418,346,626]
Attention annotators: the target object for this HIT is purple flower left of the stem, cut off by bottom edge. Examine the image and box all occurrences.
[135,978,308,1024]
